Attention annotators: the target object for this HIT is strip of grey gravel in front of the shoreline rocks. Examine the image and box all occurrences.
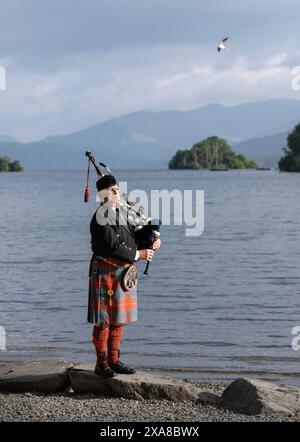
[0,382,300,422]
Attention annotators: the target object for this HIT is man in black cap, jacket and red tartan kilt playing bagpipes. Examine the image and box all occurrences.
[88,175,160,377]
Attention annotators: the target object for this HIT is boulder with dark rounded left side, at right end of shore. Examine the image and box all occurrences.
[222,379,300,415]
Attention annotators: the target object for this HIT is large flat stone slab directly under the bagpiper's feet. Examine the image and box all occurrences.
[69,365,199,402]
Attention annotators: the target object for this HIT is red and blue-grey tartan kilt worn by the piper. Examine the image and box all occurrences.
[87,258,137,324]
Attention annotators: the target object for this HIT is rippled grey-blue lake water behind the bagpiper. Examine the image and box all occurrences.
[0,170,300,386]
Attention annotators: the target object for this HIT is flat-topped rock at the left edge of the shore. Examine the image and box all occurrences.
[0,361,72,393]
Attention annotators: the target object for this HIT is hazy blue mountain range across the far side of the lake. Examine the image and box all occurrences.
[0,100,300,170]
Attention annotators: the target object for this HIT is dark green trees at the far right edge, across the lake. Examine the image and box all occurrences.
[278,124,300,172]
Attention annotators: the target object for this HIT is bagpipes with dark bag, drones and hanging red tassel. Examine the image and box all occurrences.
[84,150,161,275]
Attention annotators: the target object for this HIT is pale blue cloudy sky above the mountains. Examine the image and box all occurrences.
[0,0,300,141]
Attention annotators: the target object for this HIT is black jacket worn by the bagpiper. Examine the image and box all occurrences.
[90,209,137,264]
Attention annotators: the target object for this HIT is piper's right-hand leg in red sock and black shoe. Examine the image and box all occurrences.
[107,324,135,374]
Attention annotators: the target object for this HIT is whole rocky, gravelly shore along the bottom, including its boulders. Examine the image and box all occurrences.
[0,360,300,422]
